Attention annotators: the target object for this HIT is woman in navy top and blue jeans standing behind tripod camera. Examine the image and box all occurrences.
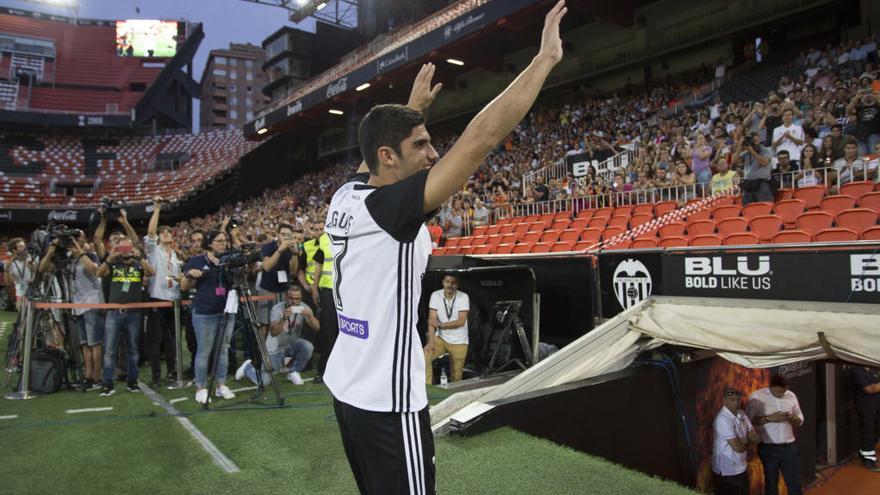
[180,230,235,404]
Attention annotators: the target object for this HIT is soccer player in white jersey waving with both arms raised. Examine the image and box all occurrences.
[324,1,566,494]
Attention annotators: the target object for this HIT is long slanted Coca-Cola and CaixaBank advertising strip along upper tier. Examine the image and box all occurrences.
[244,0,534,136]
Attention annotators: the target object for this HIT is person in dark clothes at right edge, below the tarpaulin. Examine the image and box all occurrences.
[852,366,880,472]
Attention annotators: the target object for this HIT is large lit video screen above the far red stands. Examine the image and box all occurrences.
[116,19,178,57]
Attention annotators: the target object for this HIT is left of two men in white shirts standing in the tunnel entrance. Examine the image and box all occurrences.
[712,387,759,495]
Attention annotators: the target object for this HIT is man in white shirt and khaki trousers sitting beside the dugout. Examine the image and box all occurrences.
[425,275,471,385]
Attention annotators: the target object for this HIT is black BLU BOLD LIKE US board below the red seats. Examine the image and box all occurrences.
[662,251,880,303]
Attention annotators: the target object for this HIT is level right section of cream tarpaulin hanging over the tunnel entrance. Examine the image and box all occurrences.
[630,297,880,368]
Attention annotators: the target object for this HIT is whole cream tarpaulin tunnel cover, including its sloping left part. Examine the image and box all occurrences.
[449,296,880,423]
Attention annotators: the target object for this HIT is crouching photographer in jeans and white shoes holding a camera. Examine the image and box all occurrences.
[235,285,321,385]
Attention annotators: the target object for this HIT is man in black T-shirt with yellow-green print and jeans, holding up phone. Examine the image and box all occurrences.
[98,237,155,397]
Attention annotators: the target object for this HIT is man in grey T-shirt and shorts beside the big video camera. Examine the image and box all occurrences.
[40,230,104,390]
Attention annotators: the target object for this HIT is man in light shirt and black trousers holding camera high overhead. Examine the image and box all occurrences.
[144,198,181,386]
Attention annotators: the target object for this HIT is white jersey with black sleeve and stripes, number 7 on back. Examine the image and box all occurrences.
[324,170,431,413]
